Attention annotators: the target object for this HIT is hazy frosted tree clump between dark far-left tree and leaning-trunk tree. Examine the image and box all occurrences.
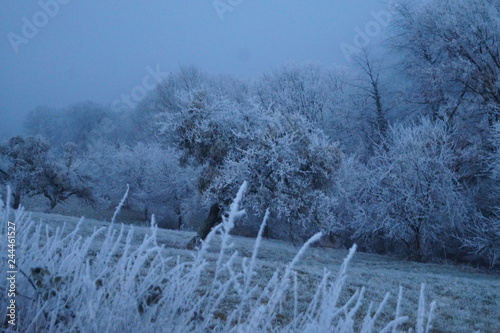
[80,143,196,227]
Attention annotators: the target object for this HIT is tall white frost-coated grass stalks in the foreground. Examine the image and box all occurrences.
[0,184,434,333]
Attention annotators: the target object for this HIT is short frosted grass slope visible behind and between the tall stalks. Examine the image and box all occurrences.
[32,213,500,333]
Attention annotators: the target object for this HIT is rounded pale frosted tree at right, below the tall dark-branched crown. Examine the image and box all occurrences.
[352,119,470,260]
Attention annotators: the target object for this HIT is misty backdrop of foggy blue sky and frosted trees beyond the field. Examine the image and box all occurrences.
[0,0,500,267]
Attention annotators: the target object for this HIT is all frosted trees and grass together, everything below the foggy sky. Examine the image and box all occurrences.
[0,0,500,333]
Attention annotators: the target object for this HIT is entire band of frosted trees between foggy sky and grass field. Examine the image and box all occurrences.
[0,0,500,269]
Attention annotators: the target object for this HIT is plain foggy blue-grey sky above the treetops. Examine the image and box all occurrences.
[0,0,386,138]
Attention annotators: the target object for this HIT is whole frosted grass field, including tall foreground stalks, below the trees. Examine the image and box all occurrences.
[0,185,500,333]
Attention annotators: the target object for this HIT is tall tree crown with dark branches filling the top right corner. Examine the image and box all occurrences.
[391,0,500,125]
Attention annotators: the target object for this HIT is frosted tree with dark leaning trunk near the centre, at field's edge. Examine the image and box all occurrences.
[158,85,260,238]
